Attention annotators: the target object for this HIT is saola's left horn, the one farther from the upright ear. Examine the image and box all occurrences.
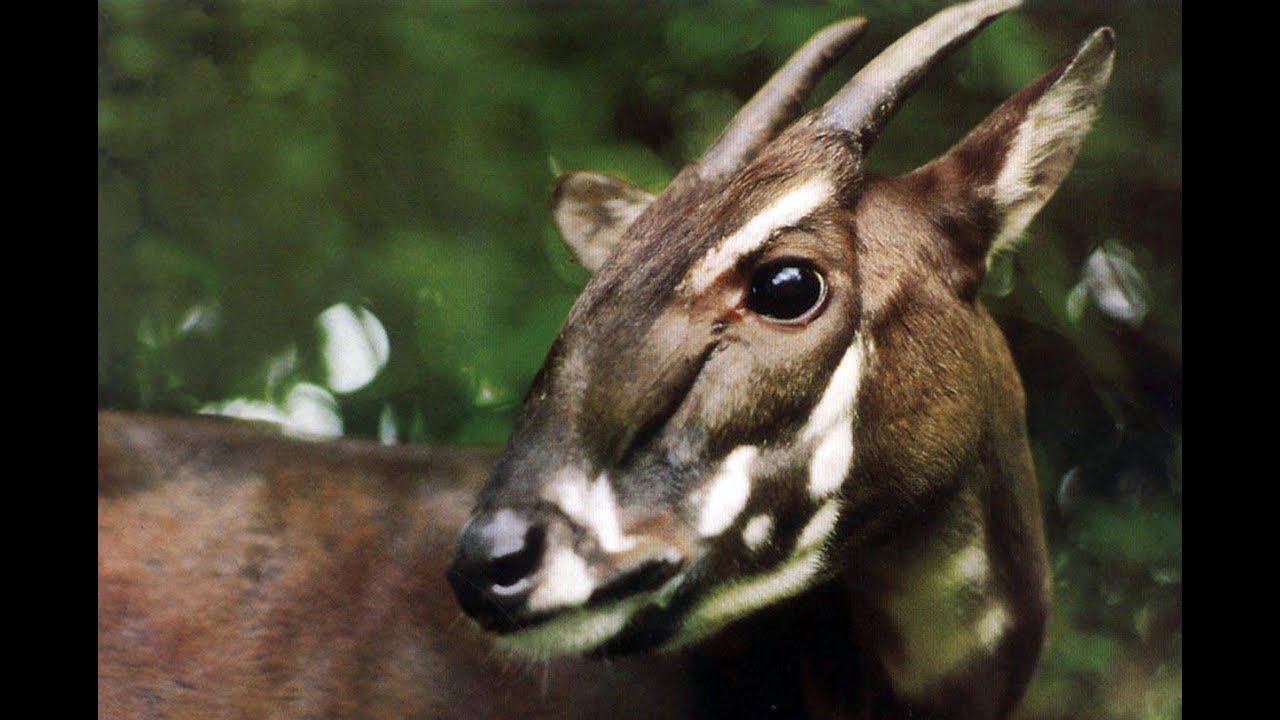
[698,18,867,179]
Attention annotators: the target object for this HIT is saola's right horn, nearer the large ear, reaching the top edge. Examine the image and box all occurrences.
[822,0,1021,151]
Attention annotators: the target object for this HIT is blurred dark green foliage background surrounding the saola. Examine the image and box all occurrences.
[97,0,1181,719]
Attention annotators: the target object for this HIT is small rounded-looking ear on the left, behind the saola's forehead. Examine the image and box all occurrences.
[552,172,654,273]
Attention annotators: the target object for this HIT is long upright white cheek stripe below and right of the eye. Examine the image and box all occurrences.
[800,334,873,500]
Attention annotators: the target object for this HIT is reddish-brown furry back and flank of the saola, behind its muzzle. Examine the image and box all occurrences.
[97,413,691,720]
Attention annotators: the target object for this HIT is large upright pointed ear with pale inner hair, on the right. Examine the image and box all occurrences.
[913,27,1115,264]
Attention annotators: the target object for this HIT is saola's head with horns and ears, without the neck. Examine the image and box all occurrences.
[449,0,1114,655]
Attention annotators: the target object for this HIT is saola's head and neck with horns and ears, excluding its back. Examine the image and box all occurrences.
[448,0,1114,717]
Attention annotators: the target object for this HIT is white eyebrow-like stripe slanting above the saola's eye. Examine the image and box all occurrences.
[682,176,836,292]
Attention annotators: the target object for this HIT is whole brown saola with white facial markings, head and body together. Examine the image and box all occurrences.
[99,1,1112,720]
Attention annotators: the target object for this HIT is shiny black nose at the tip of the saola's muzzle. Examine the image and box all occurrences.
[448,509,547,632]
